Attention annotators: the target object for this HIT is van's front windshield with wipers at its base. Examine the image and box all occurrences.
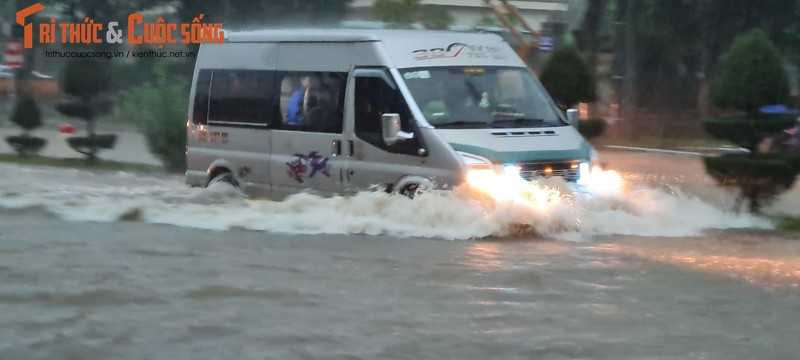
[401,67,566,129]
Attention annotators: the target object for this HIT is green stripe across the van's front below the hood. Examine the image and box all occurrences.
[450,141,591,164]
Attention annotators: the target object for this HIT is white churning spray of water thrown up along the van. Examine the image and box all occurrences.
[0,165,769,240]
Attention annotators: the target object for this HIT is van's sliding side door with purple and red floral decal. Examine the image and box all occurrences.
[270,43,352,198]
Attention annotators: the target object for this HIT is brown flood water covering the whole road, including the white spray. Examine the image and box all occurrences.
[0,150,800,359]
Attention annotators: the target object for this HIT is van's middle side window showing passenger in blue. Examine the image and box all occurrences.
[278,72,347,134]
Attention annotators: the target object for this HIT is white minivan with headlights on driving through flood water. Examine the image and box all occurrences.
[186,30,595,199]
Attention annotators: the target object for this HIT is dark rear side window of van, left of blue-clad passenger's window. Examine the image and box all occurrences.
[208,70,277,127]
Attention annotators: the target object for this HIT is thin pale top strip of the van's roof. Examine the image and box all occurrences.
[225,29,499,42]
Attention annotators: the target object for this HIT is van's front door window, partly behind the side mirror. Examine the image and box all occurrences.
[355,76,421,155]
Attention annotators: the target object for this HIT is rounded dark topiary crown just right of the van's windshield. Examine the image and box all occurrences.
[540,48,597,109]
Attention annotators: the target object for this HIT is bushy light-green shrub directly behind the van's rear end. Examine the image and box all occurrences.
[122,65,189,171]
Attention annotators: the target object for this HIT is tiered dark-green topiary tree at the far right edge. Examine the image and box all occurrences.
[703,29,800,212]
